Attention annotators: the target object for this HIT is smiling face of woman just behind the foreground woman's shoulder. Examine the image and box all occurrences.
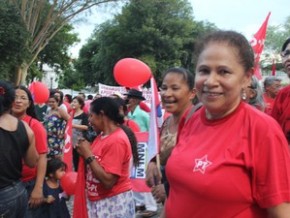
[160,72,195,115]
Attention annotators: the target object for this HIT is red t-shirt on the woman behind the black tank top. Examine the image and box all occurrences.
[22,115,47,182]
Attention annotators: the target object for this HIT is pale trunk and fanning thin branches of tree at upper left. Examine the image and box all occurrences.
[4,0,118,84]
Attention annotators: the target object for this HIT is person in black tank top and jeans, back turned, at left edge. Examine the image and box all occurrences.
[0,81,38,218]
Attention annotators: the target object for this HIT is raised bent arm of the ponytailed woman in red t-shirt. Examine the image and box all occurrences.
[77,139,118,189]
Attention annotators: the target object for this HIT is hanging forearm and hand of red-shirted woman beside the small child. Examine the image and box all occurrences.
[28,153,47,208]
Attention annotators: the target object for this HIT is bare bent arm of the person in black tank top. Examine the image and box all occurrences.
[23,122,38,167]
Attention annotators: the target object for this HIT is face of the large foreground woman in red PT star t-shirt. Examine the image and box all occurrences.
[195,42,252,119]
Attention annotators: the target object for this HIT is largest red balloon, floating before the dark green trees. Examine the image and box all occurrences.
[114,58,152,88]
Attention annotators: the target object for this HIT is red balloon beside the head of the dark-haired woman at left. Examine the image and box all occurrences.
[29,82,49,104]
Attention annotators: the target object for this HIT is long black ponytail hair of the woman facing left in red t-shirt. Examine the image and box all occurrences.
[91,97,139,165]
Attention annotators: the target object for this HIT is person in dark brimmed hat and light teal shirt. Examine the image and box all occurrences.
[125,89,149,132]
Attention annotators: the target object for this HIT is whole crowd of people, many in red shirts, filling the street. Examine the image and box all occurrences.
[0,31,290,218]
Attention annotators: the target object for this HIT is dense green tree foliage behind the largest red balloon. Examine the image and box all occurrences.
[76,0,215,85]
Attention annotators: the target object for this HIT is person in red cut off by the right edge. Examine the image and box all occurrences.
[271,38,290,145]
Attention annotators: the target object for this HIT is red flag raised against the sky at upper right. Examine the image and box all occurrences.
[250,12,271,79]
